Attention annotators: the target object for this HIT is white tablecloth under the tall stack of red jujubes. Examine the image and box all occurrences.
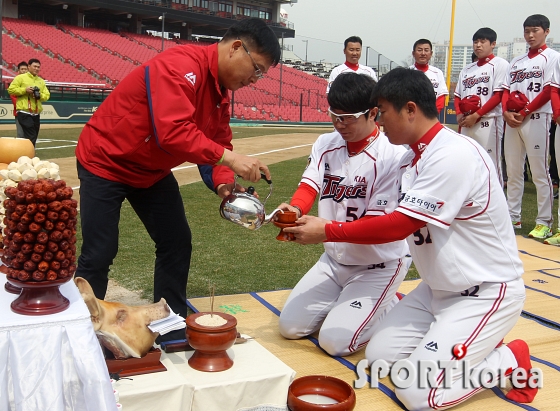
[0,274,117,411]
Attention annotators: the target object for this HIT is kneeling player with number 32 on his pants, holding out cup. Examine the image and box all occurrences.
[285,69,538,410]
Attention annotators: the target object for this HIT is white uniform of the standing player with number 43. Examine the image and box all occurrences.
[504,48,558,227]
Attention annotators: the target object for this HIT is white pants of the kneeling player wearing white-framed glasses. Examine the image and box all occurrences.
[280,253,412,356]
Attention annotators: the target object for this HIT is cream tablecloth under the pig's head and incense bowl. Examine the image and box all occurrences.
[115,340,295,411]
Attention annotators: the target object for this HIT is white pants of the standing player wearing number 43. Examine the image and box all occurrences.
[504,113,553,227]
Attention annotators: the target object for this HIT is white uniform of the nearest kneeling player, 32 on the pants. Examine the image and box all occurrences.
[366,123,525,410]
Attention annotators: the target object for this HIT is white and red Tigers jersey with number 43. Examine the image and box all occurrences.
[504,48,558,114]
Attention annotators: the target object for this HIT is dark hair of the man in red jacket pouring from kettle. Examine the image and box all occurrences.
[222,17,280,67]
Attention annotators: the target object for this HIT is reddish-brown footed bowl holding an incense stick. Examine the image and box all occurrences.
[186,312,237,372]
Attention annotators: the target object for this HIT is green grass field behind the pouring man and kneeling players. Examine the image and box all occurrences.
[2,127,558,299]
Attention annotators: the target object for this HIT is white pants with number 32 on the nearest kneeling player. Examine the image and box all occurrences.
[366,279,525,411]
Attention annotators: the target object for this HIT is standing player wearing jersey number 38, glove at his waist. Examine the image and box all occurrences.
[455,27,509,188]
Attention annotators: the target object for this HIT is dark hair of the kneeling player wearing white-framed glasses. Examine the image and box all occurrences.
[327,73,376,118]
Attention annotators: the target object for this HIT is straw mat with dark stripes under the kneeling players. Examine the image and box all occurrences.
[189,237,560,411]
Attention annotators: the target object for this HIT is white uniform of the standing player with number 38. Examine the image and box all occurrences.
[455,57,509,182]
